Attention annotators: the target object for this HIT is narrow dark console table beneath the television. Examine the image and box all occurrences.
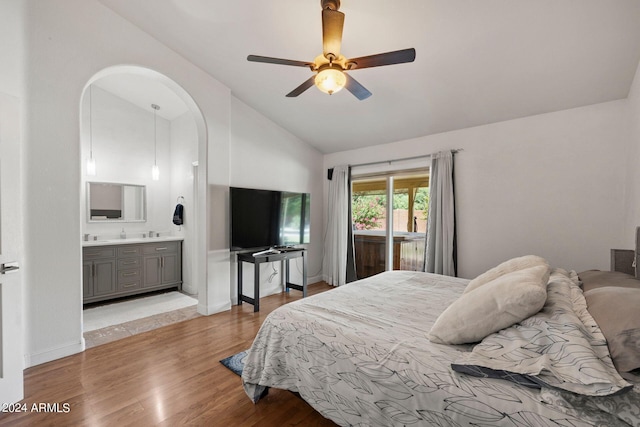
[238,249,307,312]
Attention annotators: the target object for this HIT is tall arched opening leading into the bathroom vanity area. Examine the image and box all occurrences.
[80,65,207,348]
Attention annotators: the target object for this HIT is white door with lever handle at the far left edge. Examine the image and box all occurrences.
[0,93,24,405]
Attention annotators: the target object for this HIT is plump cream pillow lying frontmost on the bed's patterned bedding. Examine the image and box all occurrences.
[427,265,550,344]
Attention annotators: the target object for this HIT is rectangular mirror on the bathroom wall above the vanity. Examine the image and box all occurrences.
[87,182,147,222]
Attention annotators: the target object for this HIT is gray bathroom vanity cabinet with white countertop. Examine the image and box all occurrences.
[82,237,182,304]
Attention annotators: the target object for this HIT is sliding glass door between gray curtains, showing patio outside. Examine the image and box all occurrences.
[352,170,429,279]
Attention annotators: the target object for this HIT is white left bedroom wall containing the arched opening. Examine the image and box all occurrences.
[16,0,322,366]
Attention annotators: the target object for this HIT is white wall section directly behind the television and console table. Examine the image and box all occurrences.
[227,97,324,300]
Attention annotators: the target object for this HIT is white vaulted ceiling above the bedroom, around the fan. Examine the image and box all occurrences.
[100,0,640,153]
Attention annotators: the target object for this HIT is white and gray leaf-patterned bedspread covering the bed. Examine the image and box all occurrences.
[242,271,628,427]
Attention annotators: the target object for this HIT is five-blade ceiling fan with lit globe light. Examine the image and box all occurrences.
[247,0,416,101]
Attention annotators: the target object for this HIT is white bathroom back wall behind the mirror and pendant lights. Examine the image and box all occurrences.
[80,85,174,238]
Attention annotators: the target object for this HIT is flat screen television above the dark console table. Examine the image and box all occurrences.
[229,187,311,251]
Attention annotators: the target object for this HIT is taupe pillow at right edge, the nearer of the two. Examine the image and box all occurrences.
[584,288,640,372]
